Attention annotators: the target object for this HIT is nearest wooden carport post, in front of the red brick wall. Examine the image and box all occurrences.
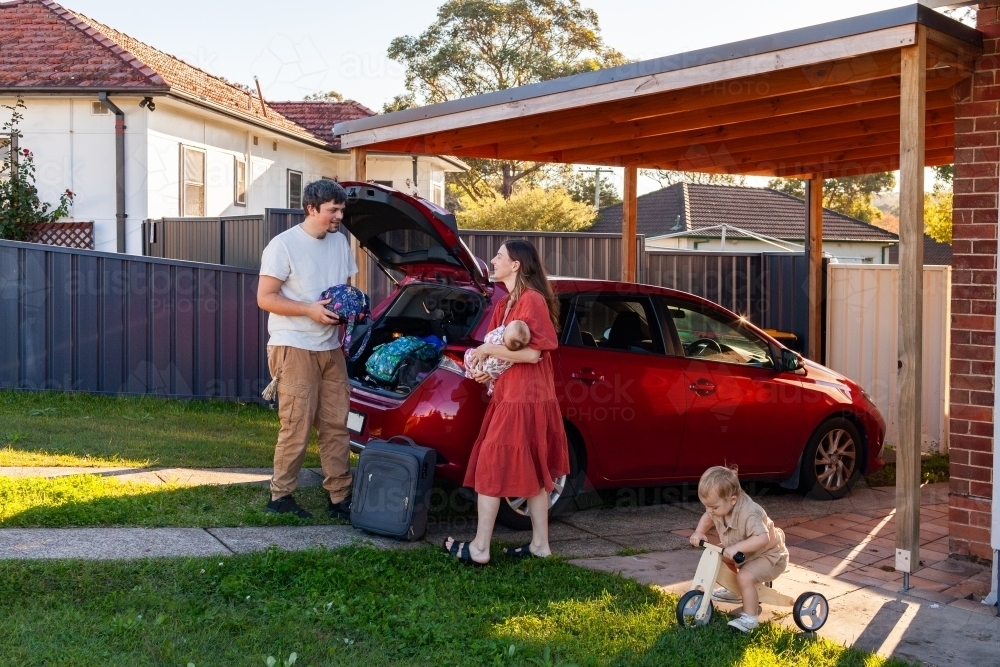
[896,26,927,590]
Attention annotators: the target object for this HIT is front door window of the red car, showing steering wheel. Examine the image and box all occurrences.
[666,301,773,368]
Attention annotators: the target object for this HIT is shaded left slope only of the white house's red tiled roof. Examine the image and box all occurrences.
[0,0,167,89]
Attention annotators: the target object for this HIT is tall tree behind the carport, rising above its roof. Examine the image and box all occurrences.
[387,0,625,204]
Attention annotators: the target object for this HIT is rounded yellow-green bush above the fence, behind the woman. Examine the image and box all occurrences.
[456,188,597,232]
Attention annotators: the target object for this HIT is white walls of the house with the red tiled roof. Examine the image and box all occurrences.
[0,94,455,254]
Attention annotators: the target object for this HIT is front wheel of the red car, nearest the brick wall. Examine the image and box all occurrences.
[799,417,862,500]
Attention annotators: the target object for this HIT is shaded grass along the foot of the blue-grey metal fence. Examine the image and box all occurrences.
[0,391,319,468]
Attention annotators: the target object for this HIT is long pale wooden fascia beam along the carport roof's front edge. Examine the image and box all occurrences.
[341,25,915,148]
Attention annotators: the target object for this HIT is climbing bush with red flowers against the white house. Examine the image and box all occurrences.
[0,97,73,241]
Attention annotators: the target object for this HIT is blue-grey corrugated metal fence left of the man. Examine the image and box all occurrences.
[0,241,268,400]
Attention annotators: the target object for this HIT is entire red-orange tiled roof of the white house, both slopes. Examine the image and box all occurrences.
[0,0,330,144]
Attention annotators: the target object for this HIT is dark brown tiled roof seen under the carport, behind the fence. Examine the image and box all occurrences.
[590,183,898,243]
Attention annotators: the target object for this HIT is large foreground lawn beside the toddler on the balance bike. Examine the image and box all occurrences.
[0,547,903,667]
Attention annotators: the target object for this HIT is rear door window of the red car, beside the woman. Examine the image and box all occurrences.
[566,294,664,354]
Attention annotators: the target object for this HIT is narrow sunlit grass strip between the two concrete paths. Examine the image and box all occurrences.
[0,475,474,528]
